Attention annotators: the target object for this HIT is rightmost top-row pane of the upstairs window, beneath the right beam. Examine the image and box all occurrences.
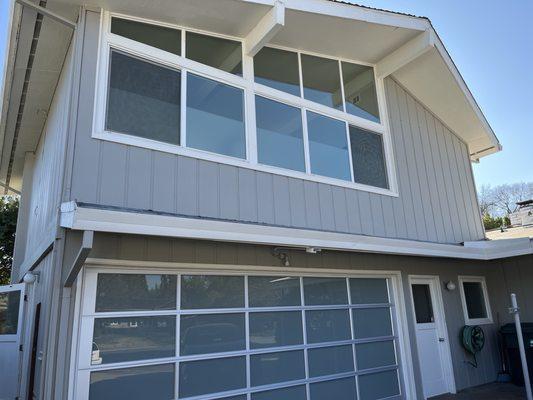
[341,62,379,122]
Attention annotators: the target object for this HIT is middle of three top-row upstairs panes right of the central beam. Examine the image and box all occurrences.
[302,54,343,110]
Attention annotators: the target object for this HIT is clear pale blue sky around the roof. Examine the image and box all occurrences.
[0,0,533,188]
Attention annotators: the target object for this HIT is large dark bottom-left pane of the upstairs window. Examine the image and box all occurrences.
[106,51,181,144]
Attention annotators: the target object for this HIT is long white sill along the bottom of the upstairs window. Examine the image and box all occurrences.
[92,131,398,197]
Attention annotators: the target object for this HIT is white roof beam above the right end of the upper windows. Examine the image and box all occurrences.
[376,29,435,78]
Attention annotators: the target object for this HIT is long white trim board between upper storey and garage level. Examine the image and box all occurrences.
[60,202,533,260]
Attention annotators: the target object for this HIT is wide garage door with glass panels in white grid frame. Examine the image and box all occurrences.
[75,269,403,400]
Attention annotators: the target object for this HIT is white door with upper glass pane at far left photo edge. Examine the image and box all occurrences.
[0,283,24,400]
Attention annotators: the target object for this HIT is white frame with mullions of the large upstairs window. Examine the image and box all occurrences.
[92,11,399,197]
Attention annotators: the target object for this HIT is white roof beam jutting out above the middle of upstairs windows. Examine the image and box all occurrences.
[244,0,285,57]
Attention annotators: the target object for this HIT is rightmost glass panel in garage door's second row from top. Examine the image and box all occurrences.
[352,308,392,339]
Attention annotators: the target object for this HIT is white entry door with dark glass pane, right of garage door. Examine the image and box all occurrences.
[410,277,455,398]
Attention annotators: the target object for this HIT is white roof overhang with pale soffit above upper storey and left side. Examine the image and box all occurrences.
[0,0,501,189]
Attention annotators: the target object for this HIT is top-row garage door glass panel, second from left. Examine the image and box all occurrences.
[181,275,244,310]
